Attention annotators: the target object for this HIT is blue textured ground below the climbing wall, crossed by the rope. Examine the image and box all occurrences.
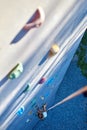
[33,55,87,130]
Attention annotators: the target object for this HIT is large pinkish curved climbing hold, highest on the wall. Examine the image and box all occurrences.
[24,7,45,30]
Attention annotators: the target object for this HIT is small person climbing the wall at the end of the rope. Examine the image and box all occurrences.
[37,104,47,119]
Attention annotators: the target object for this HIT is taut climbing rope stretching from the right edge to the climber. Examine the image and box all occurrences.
[47,86,87,111]
